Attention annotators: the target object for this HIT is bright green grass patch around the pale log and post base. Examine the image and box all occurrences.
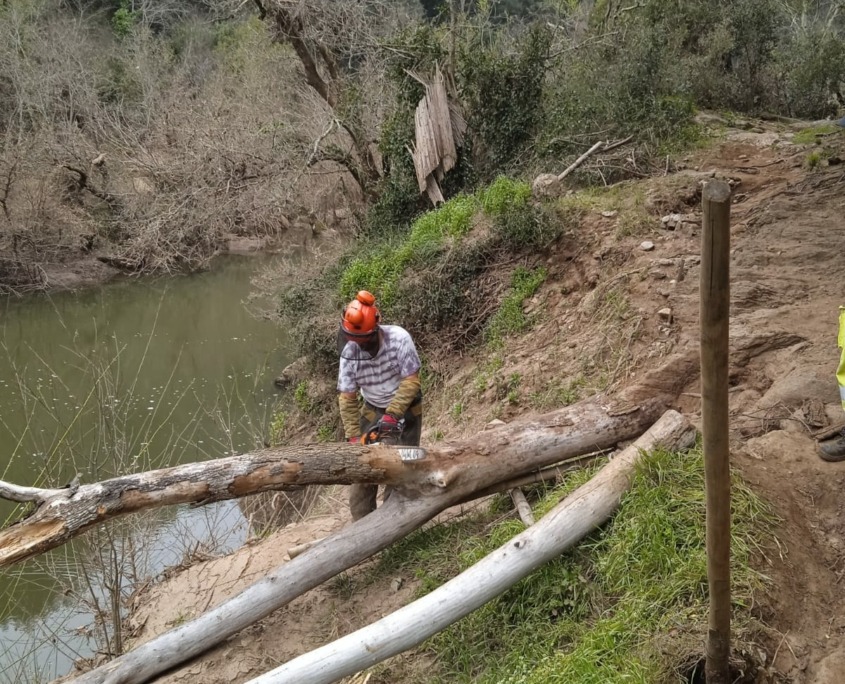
[377,448,773,684]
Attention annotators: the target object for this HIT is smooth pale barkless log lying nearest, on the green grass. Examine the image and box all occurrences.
[249,411,695,684]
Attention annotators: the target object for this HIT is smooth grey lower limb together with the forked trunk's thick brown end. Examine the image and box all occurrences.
[62,352,698,684]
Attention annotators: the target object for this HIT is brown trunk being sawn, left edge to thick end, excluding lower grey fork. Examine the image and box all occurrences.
[0,353,698,567]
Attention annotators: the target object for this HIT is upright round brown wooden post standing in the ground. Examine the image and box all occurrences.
[700,180,731,684]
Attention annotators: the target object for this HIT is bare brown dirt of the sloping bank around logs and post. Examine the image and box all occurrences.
[113,126,845,684]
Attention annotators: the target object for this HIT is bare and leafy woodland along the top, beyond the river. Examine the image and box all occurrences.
[0,0,845,292]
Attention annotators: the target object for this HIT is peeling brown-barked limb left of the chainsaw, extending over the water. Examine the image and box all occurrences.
[0,444,426,567]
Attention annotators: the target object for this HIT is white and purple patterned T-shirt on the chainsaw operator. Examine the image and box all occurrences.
[337,325,420,408]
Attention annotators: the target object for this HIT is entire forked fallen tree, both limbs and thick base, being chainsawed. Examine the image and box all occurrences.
[0,332,800,684]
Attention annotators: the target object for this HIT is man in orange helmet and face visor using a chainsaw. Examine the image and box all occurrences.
[337,290,422,520]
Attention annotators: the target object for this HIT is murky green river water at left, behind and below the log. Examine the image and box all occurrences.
[0,257,290,684]
